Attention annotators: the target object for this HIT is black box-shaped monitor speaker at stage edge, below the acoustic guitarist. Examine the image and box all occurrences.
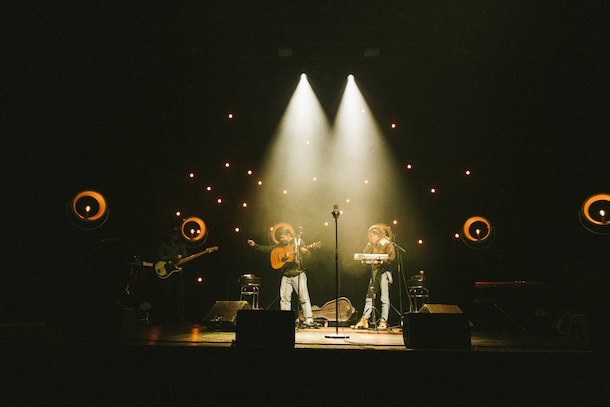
[235,310,296,348]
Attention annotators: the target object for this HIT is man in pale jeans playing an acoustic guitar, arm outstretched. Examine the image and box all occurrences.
[248,228,318,328]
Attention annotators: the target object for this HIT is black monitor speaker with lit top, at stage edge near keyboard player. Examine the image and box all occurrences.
[403,304,471,349]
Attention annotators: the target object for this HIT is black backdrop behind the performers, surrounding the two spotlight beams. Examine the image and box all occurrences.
[0,0,610,342]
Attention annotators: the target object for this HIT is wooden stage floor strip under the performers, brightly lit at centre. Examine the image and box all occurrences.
[0,321,592,352]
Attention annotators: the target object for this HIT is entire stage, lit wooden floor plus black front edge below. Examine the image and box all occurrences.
[0,321,610,406]
